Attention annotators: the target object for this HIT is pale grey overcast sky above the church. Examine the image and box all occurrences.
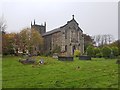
[0,0,118,39]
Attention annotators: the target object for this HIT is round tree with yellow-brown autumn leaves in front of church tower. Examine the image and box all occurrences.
[15,28,43,55]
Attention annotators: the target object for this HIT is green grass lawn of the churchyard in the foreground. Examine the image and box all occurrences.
[2,56,118,88]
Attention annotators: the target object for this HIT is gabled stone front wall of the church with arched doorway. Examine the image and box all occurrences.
[62,20,84,56]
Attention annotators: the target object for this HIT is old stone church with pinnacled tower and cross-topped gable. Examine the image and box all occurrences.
[31,15,84,56]
